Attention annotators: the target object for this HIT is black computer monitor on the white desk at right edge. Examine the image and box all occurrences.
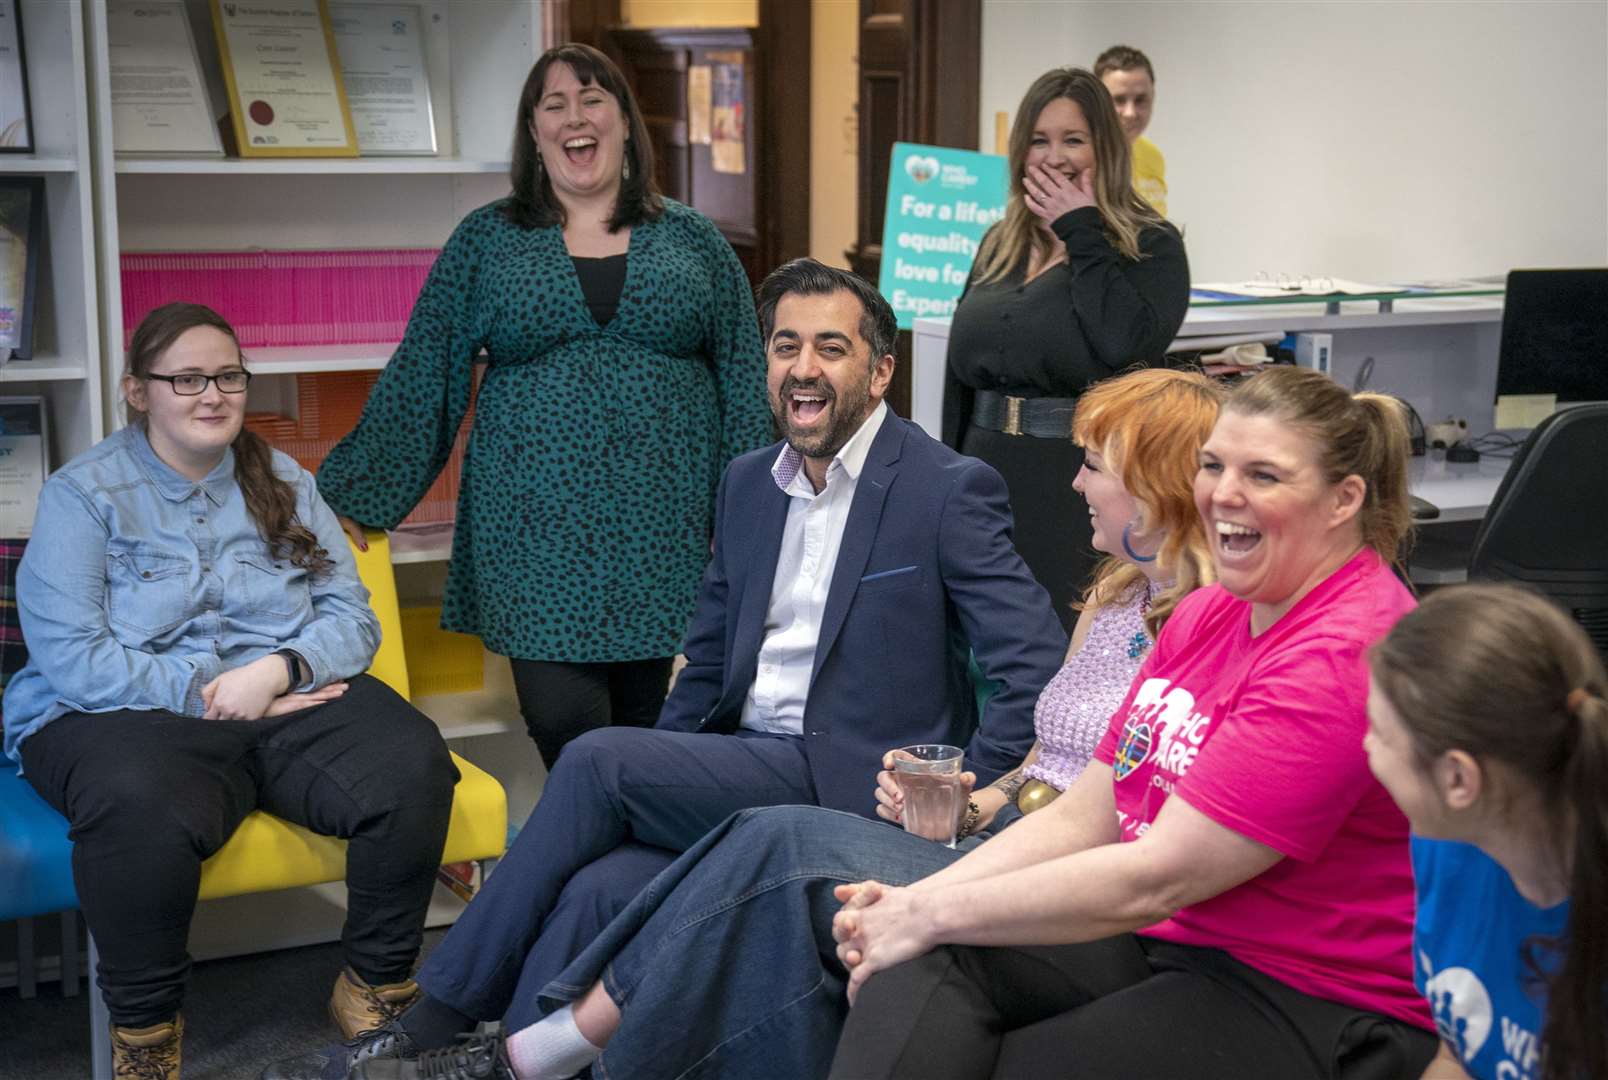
[1497,268,1608,405]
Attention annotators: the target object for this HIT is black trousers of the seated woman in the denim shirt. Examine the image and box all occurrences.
[21,675,458,1027]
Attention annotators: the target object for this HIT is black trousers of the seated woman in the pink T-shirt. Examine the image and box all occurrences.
[831,934,1436,1080]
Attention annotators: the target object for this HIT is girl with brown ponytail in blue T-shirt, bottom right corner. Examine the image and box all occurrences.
[1365,585,1608,1080]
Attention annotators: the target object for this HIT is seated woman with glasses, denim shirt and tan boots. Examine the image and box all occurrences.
[5,304,457,1077]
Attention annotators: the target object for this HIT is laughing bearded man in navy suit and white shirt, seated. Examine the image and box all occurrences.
[264,259,1071,1080]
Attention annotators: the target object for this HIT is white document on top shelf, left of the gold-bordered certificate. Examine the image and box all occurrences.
[106,0,224,158]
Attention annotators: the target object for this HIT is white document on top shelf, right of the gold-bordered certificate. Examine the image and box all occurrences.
[330,3,436,154]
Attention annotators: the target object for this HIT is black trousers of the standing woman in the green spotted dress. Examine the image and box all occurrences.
[508,656,675,771]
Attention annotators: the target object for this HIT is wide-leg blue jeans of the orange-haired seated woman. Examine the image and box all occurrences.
[542,807,962,1080]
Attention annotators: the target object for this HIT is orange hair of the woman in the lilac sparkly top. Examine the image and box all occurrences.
[1073,368,1224,636]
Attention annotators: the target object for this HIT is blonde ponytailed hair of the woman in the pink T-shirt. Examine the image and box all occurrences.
[1224,365,1412,566]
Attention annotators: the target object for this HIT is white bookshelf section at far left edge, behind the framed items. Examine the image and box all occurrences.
[0,0,105,468]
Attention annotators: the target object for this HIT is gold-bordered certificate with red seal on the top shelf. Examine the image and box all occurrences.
[212,0,357,158]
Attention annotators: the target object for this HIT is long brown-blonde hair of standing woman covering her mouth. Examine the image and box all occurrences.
[973,68,1163,284]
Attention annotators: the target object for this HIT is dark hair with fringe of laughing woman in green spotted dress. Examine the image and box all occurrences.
[505,42,664,233]
